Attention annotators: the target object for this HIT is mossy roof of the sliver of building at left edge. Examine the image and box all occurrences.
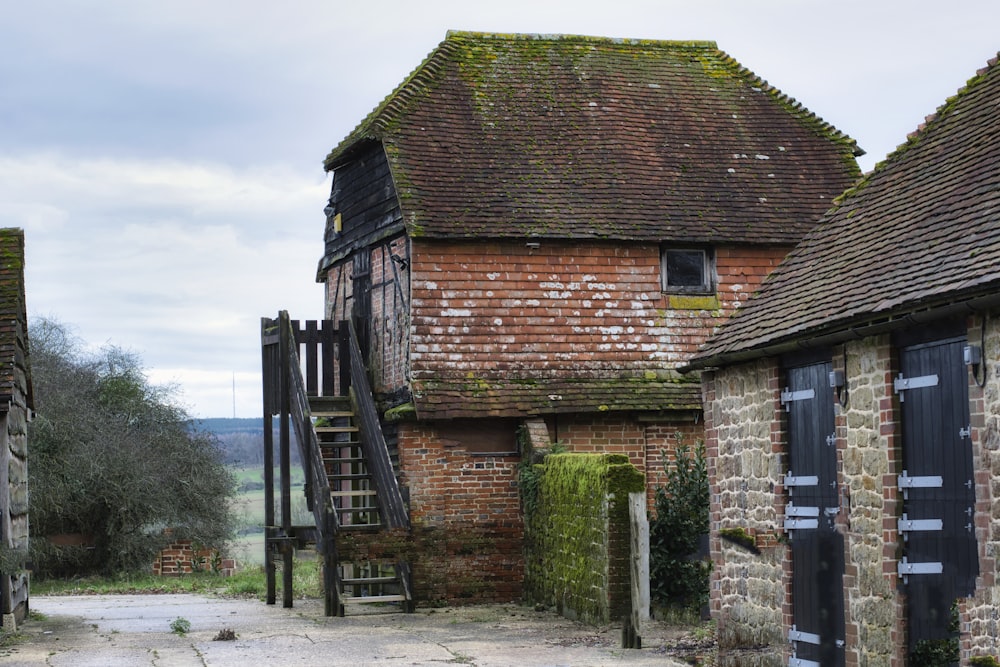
[0,228,31,411]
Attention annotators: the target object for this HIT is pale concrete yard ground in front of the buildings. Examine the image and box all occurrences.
[0,595,708,667]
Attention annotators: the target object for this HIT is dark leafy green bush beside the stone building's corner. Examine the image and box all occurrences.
[649,443,711,610]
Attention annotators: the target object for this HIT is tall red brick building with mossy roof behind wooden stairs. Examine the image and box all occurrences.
[318,32,859,599]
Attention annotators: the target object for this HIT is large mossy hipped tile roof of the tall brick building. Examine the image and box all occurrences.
[325,32,860,243]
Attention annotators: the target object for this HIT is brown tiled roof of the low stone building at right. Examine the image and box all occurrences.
[693,52,1000,367]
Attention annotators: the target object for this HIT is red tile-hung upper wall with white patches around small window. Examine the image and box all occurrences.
[411,239,787,375]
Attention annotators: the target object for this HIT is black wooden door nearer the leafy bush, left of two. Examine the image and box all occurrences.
[782,362,844,667]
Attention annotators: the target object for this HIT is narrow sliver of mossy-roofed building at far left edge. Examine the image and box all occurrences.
[0,229,33,629]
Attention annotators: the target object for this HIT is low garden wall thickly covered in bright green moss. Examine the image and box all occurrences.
[524,453,645,623]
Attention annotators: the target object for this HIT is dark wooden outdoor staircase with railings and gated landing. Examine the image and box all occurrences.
[261,311,413,616]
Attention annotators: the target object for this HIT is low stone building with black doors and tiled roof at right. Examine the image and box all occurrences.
[690,51,1000,667]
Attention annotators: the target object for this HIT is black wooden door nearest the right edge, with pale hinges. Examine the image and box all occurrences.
[896,339,979,650]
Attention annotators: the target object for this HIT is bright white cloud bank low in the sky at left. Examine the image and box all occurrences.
[0,154,328,416]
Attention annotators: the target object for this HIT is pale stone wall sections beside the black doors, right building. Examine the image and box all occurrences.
[703,313,1000,667]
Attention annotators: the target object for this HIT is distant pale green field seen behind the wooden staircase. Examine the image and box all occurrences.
[231,467,312,565]
